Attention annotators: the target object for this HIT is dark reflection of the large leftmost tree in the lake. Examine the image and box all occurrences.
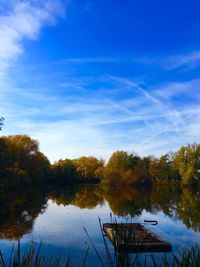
[0,187,47,240]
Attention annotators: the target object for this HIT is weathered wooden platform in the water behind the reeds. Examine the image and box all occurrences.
[103,223,172,253]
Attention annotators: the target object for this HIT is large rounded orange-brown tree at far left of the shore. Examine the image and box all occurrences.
[0,135,49,183]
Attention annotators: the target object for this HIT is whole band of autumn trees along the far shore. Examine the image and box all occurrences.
[0,119,200,186]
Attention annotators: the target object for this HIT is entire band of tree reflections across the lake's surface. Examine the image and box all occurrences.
[0,185,200,240]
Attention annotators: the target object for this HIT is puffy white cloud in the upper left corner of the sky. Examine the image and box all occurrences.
[0,0,64,78]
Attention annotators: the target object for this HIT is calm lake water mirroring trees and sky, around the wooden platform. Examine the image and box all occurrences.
[0,185,200,266]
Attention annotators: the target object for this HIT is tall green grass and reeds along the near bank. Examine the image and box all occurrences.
[0,231,200,267]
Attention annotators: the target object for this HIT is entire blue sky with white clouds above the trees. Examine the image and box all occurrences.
[0,0,200,162]
